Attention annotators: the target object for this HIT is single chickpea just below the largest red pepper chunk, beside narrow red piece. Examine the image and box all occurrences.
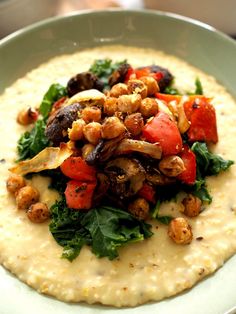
[159,156,185,177]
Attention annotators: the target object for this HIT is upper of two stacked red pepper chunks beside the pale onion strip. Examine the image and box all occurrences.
[61,157,96,181]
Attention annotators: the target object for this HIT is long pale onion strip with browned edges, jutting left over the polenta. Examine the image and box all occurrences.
[9,143,73,175]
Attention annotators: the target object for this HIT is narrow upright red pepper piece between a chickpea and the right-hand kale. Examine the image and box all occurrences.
[177,144,197,184]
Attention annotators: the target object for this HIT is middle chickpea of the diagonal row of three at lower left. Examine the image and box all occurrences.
[16,185,39,209]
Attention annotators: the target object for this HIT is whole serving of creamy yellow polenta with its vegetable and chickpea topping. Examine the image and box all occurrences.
[0,46,236,307]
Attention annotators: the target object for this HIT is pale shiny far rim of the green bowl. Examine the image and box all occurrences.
[0,8,236,48]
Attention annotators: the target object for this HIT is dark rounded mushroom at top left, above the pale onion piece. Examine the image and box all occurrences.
[67,72,104,97]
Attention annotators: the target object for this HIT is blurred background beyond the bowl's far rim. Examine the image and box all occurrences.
[0,0,236,38]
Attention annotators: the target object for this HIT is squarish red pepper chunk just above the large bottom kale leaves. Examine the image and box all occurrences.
[65,180,96,209]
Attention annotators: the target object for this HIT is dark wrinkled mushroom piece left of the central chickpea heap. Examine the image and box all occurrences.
[45,103,83,145]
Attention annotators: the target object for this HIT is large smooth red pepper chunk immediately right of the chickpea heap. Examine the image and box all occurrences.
[142,112,182,156]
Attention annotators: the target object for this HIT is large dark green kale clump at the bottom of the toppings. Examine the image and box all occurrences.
[50,199,152,261]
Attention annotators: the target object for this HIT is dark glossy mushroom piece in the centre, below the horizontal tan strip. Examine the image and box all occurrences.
[104,157,145,198]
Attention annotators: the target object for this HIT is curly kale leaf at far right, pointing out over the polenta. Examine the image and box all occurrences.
[191,142,234,177]
